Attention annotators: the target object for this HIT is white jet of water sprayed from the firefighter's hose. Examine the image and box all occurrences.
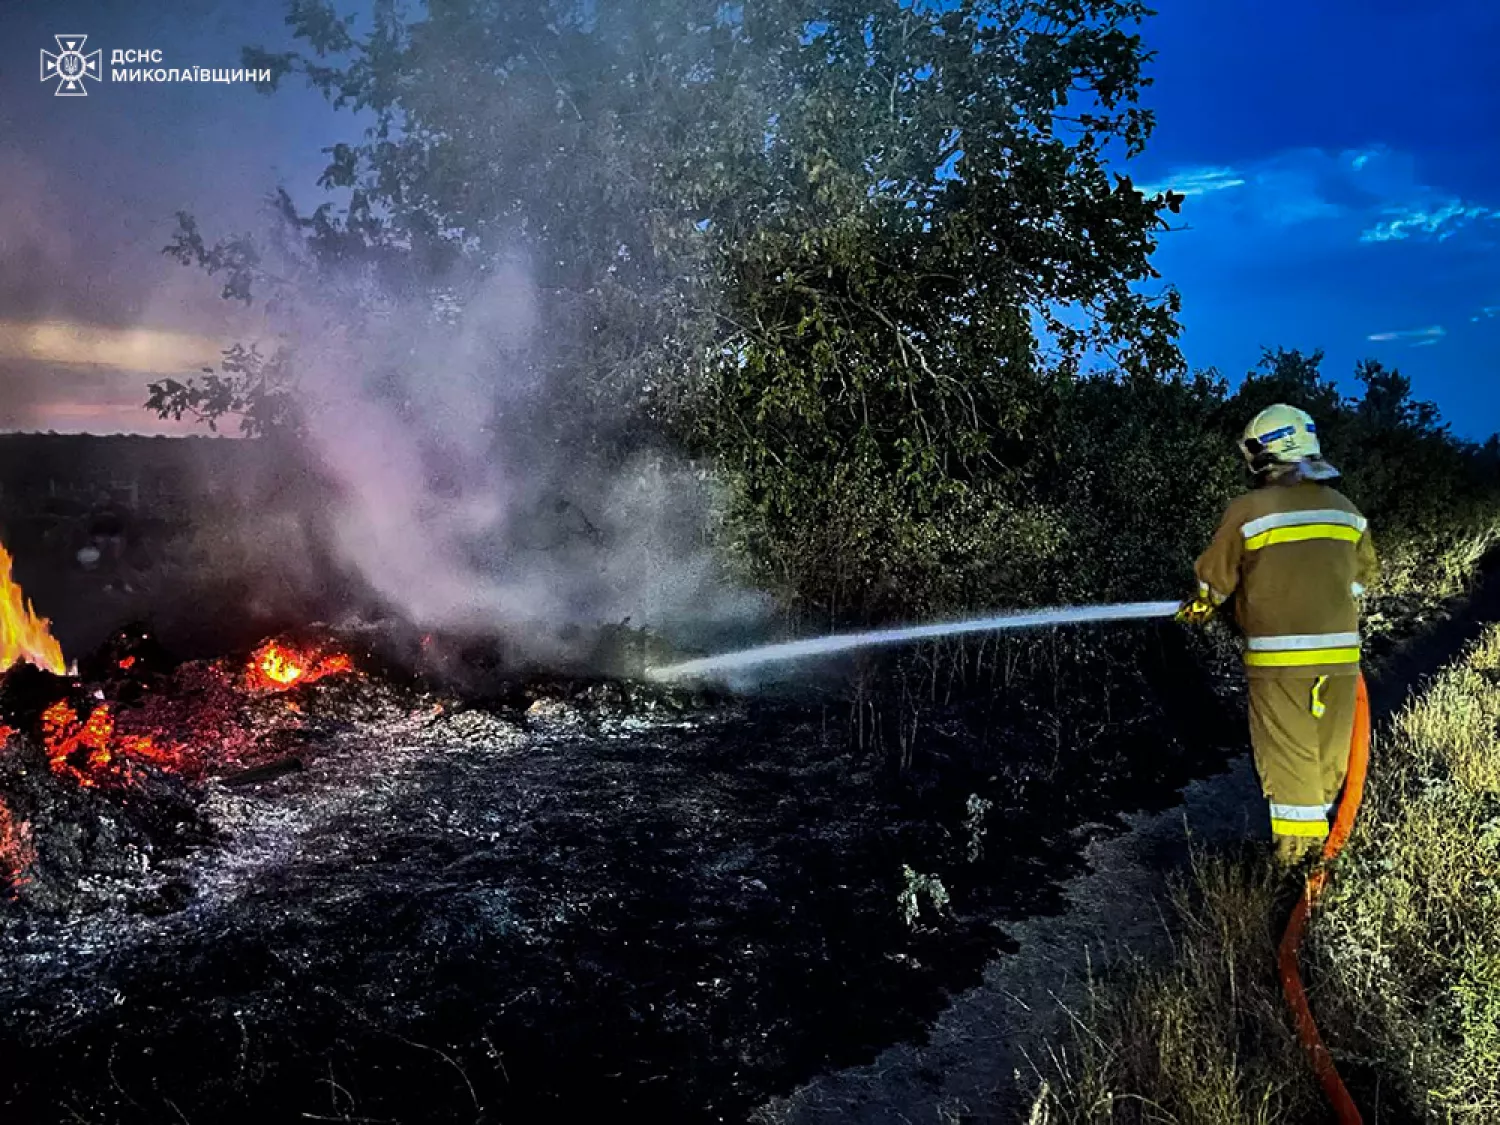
[647,602,1179,680]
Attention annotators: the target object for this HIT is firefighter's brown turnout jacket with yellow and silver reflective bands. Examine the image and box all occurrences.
[1196,479,1379,678]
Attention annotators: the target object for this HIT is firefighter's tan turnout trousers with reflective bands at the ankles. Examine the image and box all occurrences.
[1250,675,1359,863]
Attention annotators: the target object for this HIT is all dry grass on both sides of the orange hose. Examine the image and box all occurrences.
[1032,627,1500,1125]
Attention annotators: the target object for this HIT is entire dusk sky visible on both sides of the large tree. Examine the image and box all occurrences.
[0,0,1500,438]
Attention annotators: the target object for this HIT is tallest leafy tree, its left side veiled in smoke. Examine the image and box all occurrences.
[152,0,1181,627]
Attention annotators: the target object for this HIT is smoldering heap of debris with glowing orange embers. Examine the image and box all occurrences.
[0,627,707,915]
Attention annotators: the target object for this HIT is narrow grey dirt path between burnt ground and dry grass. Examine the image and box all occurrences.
[756,567,1500,1125]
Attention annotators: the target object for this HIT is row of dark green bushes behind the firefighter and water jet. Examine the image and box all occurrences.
[710,339,1500,639]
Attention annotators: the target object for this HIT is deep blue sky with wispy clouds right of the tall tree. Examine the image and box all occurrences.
[1131,0,1500,438]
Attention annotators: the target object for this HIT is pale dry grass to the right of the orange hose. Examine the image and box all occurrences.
[1310,627,1500,1125]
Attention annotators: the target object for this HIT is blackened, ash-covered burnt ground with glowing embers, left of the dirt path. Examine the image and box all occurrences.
[0,627,1242,1122]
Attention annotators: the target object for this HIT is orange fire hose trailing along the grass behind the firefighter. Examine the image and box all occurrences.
[1278,675,1370,1125]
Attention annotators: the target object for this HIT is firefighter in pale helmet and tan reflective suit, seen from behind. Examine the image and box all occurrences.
[1178,405,1377,866]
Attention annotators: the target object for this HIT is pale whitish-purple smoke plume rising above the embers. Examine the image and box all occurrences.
[277,261,764,654]
